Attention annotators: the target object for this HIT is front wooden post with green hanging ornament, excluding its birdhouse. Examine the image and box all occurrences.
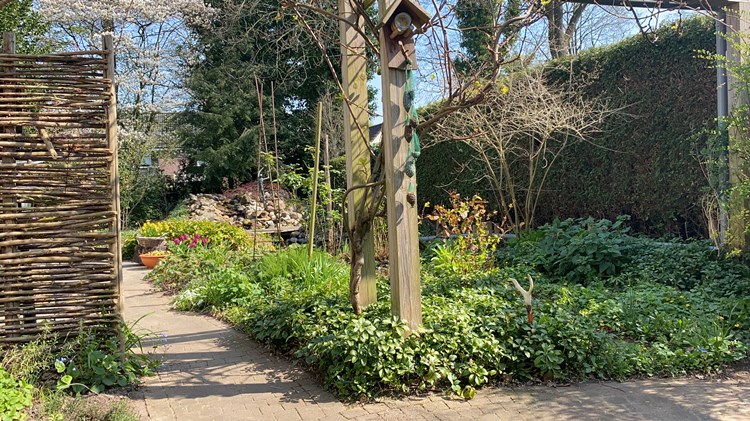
[378,0,422,329]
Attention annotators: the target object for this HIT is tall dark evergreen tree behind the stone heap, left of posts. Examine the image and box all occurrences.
[183,0,340,190]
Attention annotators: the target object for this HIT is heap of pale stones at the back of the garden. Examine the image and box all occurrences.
[187,192,302,231]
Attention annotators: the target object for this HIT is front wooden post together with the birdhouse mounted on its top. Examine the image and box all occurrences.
[378,0,430,330]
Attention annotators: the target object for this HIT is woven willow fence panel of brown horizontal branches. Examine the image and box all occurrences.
[0,34,122,345]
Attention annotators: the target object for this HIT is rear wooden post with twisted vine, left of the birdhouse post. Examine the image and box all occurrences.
[339,0,377,308]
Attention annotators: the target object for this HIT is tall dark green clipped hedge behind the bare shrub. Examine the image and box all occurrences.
[418,18,716,235]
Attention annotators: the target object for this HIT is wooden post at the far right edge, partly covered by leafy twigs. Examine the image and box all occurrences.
[726,3,750,250]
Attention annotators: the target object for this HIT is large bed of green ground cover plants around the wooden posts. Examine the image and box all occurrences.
[149,220,750,400]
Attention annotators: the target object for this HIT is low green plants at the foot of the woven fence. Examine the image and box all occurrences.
[0,325,159,421]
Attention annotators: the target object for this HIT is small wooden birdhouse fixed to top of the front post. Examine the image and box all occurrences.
[381,0,430,69]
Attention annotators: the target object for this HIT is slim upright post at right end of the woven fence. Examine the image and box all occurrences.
[102,34,127,344]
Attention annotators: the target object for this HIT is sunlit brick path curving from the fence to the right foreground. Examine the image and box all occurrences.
[124,265,750,421]
